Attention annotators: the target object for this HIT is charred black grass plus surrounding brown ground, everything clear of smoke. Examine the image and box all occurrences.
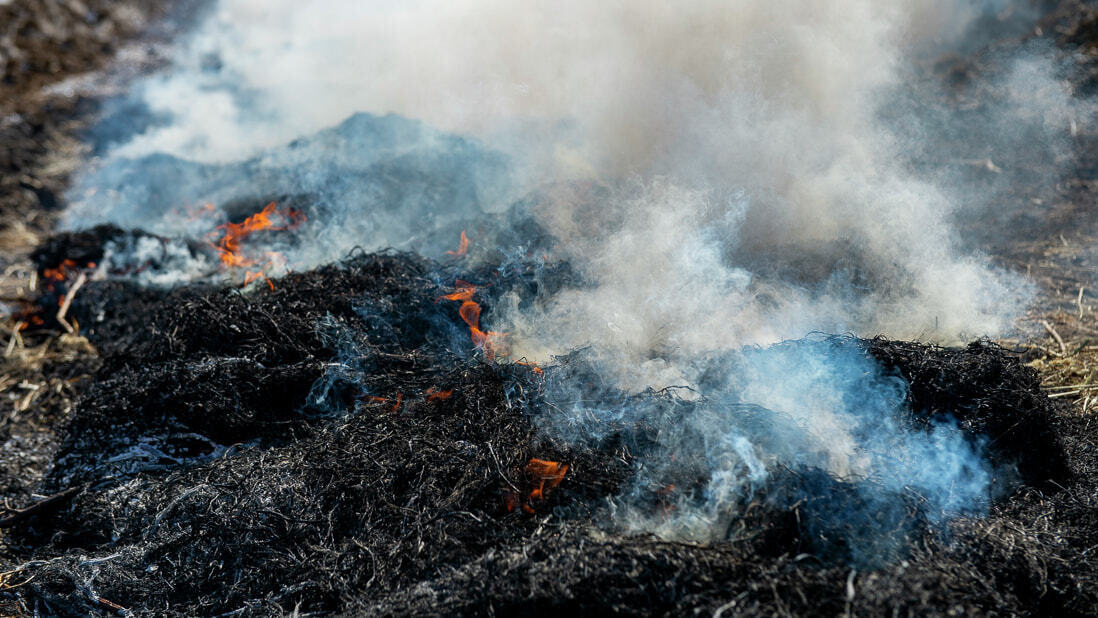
[0,0,1098,616]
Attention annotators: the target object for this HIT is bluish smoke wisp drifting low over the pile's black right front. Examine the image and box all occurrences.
[538,337,993,564]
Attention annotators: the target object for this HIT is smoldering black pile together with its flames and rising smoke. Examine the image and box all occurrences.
[0,0,1098,616]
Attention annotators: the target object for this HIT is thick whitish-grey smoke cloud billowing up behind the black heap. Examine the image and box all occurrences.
[64,0,1077,358]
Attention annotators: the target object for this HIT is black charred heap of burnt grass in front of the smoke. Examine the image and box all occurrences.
[0,239,1098,616]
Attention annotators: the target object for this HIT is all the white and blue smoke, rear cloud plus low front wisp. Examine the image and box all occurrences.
[55,0,1091,557]
